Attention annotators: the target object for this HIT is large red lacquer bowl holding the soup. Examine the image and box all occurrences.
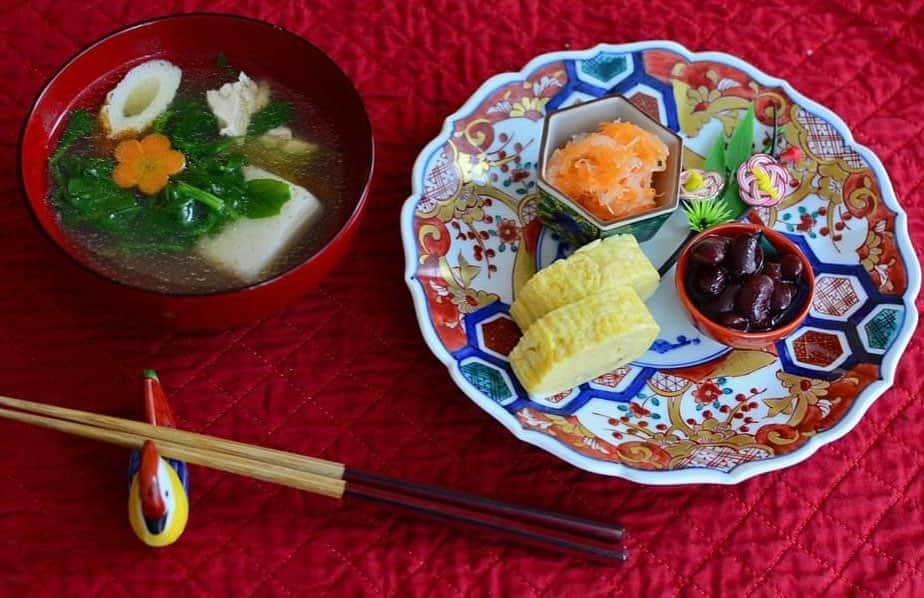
[20,14,373,329]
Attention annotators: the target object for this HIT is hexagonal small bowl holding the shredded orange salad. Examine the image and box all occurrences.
[538,95,683,247]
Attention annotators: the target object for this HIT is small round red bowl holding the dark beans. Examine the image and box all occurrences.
[674,222,815,349]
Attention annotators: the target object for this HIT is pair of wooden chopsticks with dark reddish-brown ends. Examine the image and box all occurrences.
[0,396,627,562]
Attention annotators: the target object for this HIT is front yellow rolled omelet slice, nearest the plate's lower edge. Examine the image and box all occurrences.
[509,287,659,397]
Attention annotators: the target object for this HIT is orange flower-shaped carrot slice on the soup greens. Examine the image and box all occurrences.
[112,133,186,195]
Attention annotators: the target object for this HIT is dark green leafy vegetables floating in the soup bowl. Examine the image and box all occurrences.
[49,89,304,255]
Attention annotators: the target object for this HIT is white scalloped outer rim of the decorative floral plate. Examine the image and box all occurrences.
[401,40,921,486]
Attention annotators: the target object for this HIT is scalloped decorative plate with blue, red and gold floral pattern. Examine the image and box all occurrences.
[401,42,921,484]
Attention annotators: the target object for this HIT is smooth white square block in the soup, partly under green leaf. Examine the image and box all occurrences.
[196,166,324,283]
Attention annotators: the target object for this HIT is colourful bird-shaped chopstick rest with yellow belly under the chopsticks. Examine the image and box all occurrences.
[128,370,189,547]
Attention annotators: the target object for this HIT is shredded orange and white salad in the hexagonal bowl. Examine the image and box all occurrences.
[546,121,668,222]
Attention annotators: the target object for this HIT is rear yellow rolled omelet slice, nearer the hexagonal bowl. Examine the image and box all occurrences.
[510,235,660,331]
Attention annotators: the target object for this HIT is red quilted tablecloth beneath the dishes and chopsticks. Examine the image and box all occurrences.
[0,0,924,596]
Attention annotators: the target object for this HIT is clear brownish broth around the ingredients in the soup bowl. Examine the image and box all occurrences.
[48,62,344,294]
